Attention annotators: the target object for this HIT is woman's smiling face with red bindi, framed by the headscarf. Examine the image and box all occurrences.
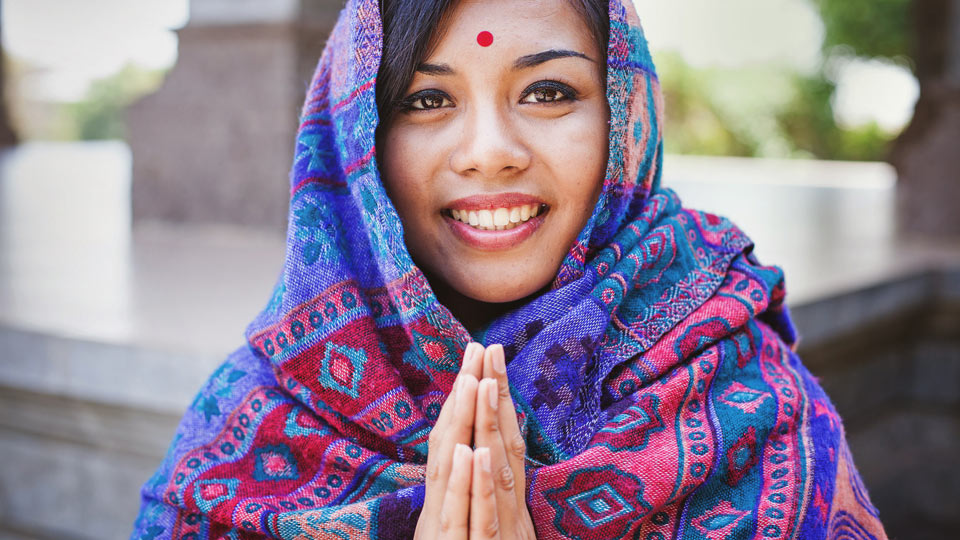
[378,0,609,303]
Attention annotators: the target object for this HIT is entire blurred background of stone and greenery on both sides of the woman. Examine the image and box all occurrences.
[0,0,960,540]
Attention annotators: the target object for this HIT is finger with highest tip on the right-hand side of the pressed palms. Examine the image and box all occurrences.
[483,344,527,504]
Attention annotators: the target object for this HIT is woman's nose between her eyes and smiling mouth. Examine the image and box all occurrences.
[450,105,531,178]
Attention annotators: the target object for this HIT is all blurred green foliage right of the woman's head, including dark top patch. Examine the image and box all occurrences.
[656,0,909,161]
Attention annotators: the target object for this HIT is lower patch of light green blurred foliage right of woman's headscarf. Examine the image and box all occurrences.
[656,54,897,161]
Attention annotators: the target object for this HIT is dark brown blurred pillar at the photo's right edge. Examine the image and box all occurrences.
[892,0,960,237]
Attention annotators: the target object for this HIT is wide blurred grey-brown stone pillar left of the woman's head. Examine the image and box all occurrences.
[127,0,341,231]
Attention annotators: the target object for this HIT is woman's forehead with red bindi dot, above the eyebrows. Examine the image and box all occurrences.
[426,0,597,62]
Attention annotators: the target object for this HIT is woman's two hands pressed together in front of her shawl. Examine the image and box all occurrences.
[415,343,536,540]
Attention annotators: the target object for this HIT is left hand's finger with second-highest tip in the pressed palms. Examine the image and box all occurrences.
[423,375,478,528]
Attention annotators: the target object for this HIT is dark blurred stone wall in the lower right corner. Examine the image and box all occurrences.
[794,269,960,540]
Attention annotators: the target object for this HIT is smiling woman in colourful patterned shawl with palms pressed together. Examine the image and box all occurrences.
[133,0,885,540]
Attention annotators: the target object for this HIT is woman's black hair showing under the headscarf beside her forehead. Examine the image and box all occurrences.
[377,0,610,125]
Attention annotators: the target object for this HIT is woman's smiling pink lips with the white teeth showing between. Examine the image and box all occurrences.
[443,193,549,251]
